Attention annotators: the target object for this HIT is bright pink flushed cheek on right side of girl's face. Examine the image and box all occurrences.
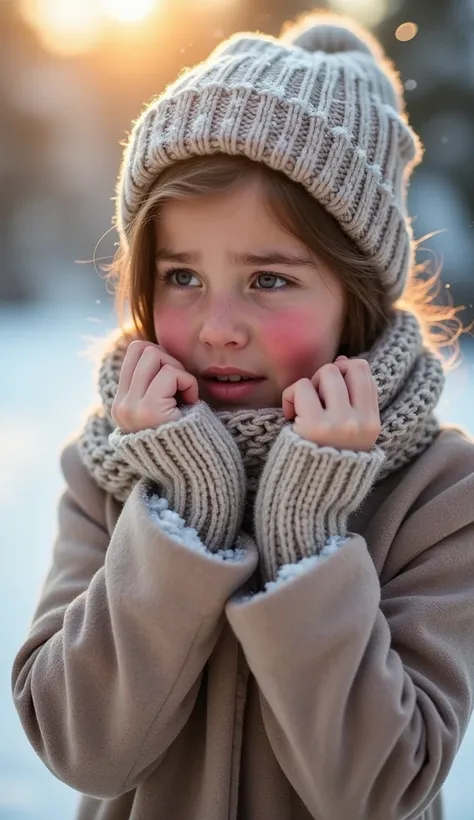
[260,310,330,386]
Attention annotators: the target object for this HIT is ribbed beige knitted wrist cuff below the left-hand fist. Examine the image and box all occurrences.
[109,401,245,552]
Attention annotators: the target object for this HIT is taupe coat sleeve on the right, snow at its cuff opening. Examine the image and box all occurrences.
[226,432,474,820]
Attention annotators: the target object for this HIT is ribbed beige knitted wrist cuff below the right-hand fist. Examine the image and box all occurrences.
[255,425,385,581]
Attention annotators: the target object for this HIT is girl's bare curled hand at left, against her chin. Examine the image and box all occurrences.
[111,340,199,433]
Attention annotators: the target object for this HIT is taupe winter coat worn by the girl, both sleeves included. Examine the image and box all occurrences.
[13,416,474,820]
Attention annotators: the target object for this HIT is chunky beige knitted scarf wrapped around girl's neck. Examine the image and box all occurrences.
[79,310,444,502]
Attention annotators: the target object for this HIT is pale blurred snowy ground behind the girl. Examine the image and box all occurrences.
[0,304,474,820]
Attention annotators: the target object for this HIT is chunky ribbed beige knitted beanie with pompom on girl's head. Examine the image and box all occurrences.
[116,12,422,301]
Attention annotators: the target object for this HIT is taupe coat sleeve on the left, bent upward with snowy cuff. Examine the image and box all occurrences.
[13,444,257,798]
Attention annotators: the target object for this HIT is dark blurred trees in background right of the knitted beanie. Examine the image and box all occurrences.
[375,0,474,310]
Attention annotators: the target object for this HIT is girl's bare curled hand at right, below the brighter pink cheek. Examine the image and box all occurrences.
[282,356,381,451]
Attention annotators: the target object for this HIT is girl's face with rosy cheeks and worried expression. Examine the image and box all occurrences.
[154,181,344,409]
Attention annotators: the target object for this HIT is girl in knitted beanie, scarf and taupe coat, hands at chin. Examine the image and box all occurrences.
[13,14,474,820]
